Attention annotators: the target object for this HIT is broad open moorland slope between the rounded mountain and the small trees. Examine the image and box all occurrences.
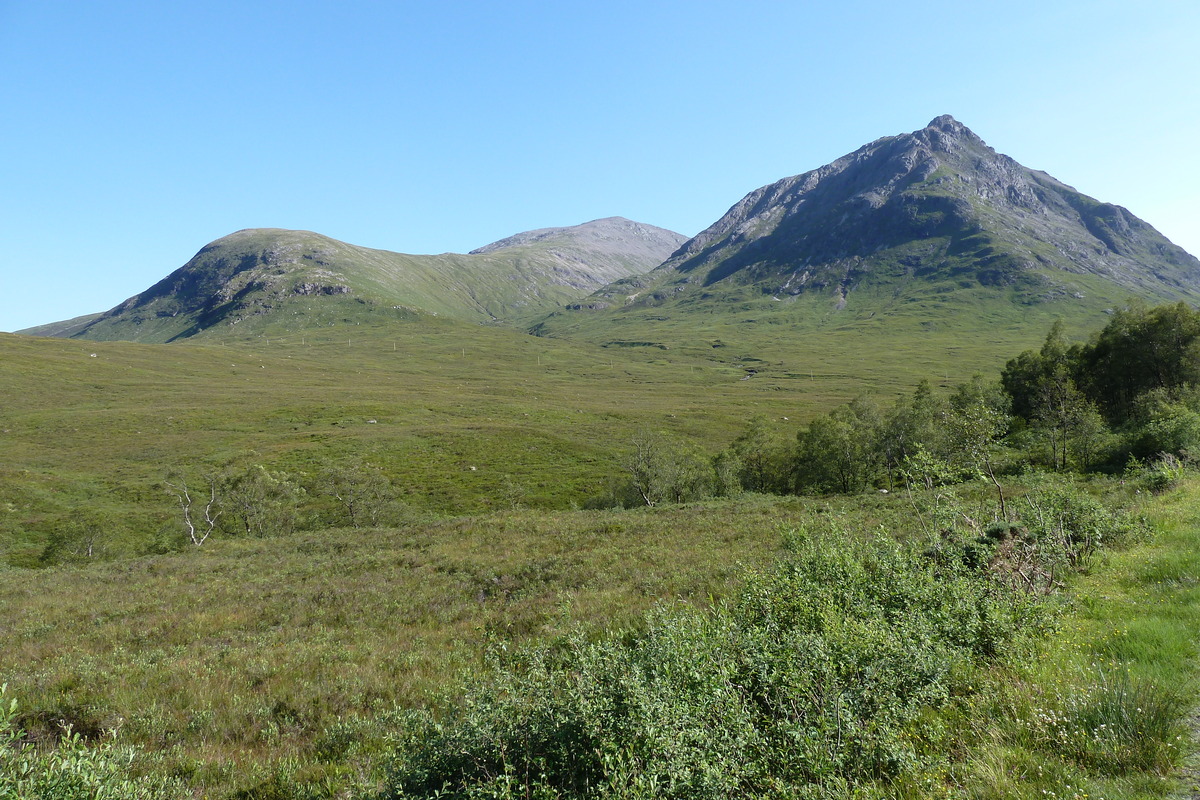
[0,320,827,565]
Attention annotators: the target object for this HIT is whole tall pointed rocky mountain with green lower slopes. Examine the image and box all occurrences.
[535,116,1200,347]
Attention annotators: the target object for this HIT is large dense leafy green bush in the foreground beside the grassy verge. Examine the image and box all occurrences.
[386,531,1038,798]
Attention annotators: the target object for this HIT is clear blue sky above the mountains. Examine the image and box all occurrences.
[0,0,1200,331]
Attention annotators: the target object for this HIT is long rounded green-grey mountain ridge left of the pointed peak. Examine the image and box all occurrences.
[37,217,685,342]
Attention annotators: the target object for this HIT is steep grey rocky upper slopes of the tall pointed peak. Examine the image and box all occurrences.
[654,115,1200,307]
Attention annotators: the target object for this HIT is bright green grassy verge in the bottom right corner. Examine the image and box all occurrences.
[960,477,1200,800]
